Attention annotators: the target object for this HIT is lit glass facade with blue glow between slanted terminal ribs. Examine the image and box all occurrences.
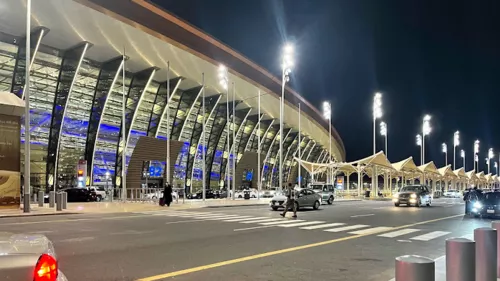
[0,33,336,191]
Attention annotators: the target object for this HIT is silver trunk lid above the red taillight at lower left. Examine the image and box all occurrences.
[0,232,55,256]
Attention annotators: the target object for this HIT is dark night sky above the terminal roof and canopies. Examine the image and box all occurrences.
[153,0,500,170]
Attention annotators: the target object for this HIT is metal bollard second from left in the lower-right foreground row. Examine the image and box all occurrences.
[446,238,476,281]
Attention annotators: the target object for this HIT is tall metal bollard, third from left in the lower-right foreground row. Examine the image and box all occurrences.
[474,227,497,281]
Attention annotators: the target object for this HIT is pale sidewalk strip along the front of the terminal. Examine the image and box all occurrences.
[0,198,360,218]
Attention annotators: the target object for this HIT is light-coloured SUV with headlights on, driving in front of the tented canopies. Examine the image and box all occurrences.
[392,185,432,207]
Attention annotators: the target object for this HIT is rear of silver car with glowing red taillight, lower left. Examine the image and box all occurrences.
[0,232,68,281]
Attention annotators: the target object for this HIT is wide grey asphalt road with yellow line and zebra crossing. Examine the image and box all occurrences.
[0,199,490,281]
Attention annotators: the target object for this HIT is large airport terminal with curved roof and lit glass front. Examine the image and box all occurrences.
[0,0,345,190]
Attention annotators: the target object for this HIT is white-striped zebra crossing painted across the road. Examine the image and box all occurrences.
[140,211,451,241]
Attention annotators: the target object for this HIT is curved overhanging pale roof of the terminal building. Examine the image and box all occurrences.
[0,0,345,161]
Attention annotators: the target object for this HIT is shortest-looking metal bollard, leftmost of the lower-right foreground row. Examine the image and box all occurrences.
[395,255,436,281]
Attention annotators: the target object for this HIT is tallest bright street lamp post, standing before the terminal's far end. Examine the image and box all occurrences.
[279,44,294,188]
